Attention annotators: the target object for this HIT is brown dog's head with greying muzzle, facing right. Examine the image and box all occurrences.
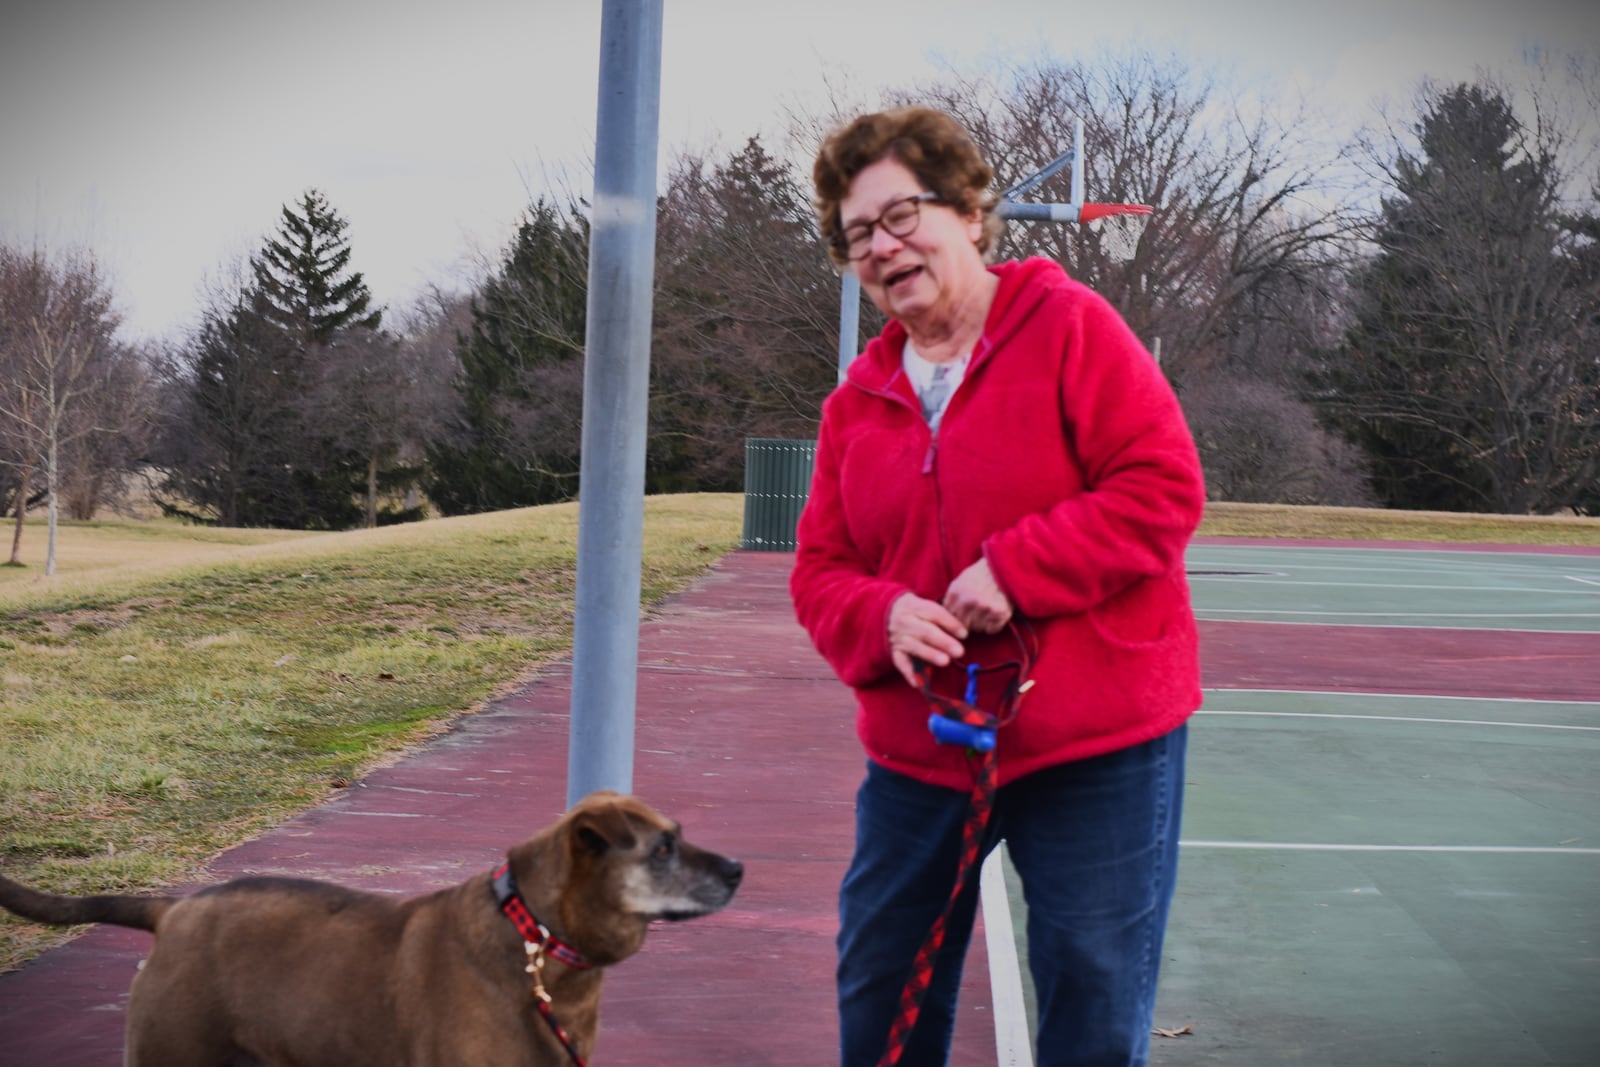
[512,792,744,963]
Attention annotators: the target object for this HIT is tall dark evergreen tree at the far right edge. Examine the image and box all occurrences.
[1317,85,1600,514]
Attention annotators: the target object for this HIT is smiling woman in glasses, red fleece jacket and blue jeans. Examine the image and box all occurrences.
[790,107,1205,1067]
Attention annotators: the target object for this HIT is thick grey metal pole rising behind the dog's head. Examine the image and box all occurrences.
[566,0,662,806]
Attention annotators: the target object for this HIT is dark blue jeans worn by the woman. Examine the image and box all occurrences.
[838,726,1187,1067]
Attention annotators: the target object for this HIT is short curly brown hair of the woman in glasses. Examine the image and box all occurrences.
[811,107,1002,266]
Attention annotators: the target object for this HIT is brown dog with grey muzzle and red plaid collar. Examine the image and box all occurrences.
[0,793,744,1067]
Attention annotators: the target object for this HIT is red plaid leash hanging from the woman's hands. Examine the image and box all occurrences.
[878,621,1034,1067]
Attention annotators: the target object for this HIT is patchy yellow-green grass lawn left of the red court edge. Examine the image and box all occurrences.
[0,494,742,969]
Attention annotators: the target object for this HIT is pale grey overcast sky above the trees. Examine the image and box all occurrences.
[0,0,1600,336]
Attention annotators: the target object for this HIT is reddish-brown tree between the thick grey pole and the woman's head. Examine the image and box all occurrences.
[648,138,838,491]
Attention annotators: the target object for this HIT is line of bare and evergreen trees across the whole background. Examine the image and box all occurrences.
[0,53,1600,560]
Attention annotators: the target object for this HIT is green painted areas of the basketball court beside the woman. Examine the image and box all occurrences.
[986,545,1600,1067]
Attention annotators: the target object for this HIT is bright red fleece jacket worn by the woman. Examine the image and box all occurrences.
[790,259,1205,789]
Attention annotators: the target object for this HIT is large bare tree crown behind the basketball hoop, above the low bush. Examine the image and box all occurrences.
[904,51,1354,387]
